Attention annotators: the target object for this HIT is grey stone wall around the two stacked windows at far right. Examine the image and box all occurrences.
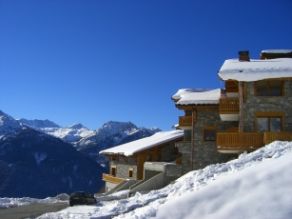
[243,80,292,132]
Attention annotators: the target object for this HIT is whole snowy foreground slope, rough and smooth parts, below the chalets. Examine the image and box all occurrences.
[39,142,292,219]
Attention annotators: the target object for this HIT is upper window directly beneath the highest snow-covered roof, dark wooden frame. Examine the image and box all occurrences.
[255,80,284,96]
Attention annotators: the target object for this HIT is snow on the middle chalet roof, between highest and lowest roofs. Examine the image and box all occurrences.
[174,88,221,105]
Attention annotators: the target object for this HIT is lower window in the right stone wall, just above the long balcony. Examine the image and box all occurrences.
[256,117,282,132]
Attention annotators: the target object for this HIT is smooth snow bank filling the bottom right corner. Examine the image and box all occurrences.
[157,145,292,219]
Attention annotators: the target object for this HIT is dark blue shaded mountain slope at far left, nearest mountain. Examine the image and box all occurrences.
[0,111,104,198]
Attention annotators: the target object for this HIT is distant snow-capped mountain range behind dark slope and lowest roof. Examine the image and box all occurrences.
[19,119,160,163]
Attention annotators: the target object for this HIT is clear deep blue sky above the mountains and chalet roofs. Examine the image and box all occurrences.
[0,0,292,129]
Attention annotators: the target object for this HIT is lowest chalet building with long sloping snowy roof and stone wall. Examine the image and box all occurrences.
[100,130,183,192]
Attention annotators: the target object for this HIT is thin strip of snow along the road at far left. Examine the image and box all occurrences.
[0,194,69,209]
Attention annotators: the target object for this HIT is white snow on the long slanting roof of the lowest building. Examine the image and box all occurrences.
[99,130,184,157]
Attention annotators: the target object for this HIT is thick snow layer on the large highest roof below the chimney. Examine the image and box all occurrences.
[218,58,292,81]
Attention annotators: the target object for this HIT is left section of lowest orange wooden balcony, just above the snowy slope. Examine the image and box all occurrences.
[217,132,264,153]
